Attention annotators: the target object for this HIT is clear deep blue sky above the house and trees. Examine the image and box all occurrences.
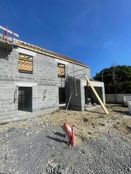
[0,0,131,76]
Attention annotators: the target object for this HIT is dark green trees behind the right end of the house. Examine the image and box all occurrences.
[94,65,131,94]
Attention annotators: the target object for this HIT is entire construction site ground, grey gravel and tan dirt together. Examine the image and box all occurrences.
[0,105,131,174]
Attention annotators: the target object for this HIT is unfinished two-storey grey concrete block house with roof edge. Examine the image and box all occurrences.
[0,28,105,120]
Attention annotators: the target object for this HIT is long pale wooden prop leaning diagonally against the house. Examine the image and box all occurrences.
[85,75,109,115]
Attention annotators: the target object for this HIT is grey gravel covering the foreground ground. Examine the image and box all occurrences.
[0,104,131,174]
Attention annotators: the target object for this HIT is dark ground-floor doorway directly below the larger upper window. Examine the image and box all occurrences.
[18,87,32,112]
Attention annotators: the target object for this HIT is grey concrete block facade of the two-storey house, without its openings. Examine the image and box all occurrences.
[0,45,90,118]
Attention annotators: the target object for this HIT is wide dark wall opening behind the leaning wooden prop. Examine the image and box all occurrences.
[85,86,103,104]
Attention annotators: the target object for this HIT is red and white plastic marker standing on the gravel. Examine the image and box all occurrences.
[64,121,75,146]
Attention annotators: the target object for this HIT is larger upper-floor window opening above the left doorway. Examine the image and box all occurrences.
[18,53,33,74]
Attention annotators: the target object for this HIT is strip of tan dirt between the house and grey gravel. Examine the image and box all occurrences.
[0,104,131,144]
